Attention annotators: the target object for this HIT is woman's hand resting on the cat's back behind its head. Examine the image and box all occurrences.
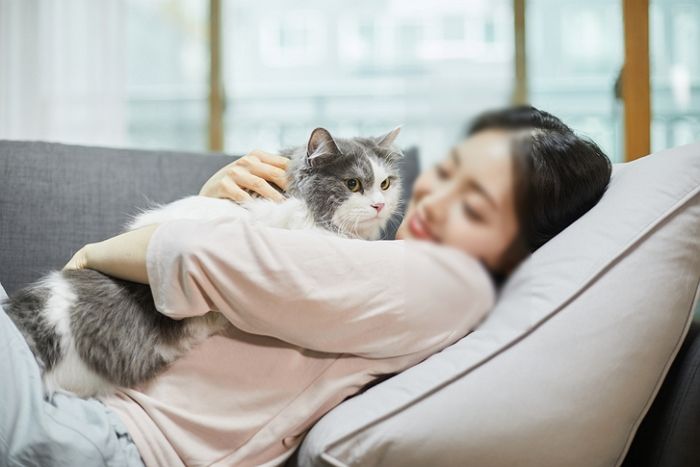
[199,150,289,204]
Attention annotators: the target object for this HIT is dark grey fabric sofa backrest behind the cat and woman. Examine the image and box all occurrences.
[0,141,418,294]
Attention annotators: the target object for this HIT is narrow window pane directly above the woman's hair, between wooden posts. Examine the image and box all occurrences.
[526,0,624,161]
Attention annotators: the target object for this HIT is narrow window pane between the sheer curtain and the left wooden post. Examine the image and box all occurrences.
[125,0,209,151]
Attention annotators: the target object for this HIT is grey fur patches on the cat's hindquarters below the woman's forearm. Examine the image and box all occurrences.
[3,269,225,396]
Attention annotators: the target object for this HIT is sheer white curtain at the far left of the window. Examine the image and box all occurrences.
[0,0,127,145]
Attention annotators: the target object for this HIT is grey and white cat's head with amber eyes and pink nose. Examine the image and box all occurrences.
[290,128,403,239]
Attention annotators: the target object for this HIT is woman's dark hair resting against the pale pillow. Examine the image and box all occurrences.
[468,106,612,274]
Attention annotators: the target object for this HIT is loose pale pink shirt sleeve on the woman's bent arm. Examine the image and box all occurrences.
[147,219,494,358]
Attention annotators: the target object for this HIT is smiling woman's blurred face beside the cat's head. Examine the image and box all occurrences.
[396,130,518,272]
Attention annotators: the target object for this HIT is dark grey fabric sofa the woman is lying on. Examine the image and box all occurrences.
[0,141,700,467]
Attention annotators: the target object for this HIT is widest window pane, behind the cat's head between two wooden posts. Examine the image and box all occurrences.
[222,0,513,164]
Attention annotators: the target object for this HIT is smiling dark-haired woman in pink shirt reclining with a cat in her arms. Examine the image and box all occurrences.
[0,107,611,466]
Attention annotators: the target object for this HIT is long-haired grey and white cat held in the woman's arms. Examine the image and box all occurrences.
[3,128,402,397]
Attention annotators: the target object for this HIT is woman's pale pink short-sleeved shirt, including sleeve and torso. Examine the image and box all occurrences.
[104,219,494,467]
